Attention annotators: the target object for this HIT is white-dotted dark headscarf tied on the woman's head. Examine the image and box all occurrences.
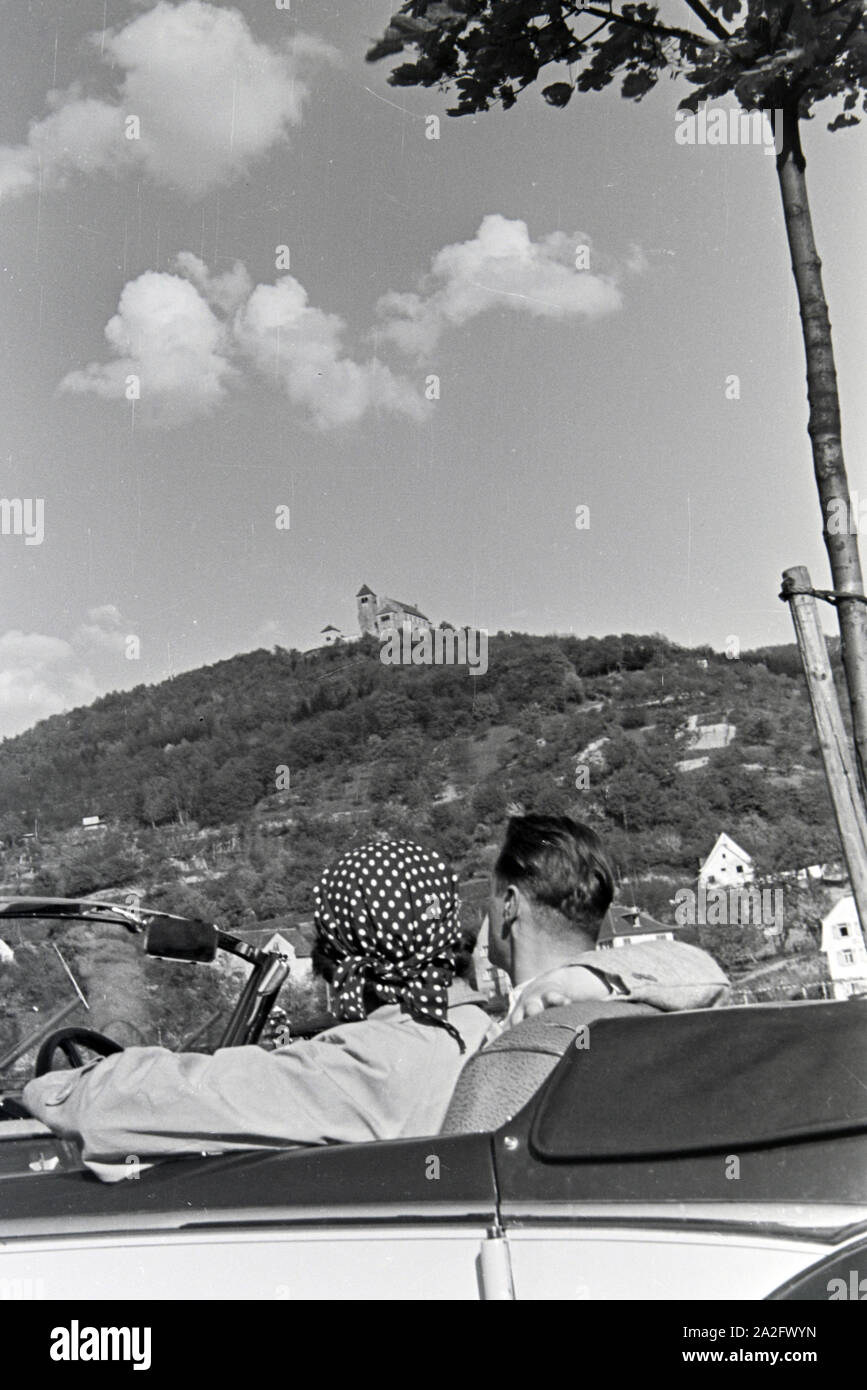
[314,840,464,1052]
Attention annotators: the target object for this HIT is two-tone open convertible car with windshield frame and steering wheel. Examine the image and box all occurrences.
[0,898,867,1302]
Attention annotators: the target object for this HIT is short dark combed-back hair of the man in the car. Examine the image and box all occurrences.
[493,816,614,935]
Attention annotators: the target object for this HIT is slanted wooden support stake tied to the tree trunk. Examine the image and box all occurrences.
[779,564,867,933]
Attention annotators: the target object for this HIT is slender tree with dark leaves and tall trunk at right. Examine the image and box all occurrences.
[368,0,867,790]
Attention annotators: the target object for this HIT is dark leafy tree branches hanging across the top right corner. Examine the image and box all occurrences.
[368,0,867,129]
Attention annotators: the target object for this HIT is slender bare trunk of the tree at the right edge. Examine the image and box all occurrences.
[777,108,867,799]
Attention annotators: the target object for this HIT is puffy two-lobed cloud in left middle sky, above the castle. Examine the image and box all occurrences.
[60,252,429,430]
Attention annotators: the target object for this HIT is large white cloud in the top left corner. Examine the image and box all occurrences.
[0,0,336,197]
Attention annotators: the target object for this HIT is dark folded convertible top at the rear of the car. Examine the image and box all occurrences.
[531,999,867,1162]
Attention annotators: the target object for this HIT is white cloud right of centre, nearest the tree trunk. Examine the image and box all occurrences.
[377,213,621,357]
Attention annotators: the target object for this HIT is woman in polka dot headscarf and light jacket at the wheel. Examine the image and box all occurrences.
[24,841,490,1182]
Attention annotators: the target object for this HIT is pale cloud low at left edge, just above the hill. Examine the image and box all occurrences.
[0,603,140,738]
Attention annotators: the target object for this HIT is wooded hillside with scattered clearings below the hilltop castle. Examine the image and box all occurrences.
[0,634,838,920]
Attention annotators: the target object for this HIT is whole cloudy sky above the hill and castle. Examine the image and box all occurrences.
[0,0,867,737]
